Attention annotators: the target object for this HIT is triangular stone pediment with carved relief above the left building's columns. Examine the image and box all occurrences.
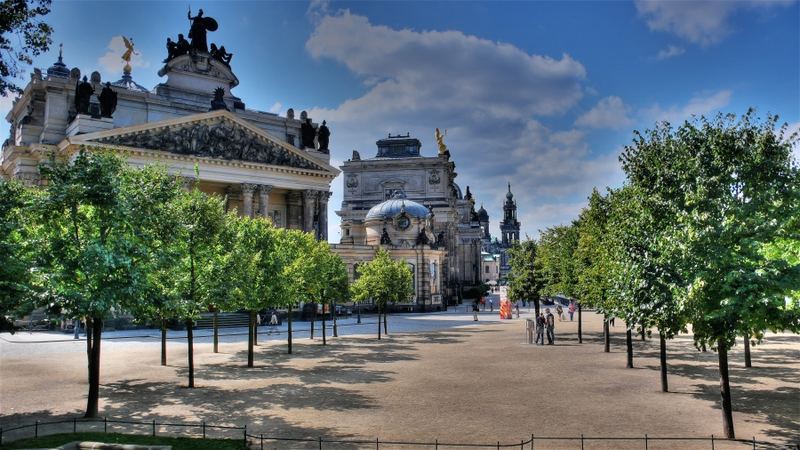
[68,110,339,176]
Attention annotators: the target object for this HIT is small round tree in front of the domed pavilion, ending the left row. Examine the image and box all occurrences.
[352,249,414,339]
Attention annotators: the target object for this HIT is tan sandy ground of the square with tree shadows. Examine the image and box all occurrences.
[0,313,800,449]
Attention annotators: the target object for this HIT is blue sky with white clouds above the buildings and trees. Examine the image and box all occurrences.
[0,0,800,241]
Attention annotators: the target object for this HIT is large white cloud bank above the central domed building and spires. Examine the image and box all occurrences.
[306,12,622,241]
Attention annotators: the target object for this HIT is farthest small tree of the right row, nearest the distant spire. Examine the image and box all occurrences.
[508,239,544,317]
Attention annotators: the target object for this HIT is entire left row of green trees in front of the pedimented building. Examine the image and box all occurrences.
[0,151,411,417]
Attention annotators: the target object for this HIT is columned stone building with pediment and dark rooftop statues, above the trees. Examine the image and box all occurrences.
[0,13,339,239]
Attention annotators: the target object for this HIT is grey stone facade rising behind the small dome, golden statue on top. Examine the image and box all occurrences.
[335,135,481,303]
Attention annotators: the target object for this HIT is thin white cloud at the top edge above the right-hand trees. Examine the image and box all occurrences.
[636,0,792,46]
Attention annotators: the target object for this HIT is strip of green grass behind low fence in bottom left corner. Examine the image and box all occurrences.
[0,433,245,450]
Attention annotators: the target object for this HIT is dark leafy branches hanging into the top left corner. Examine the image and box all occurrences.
[0,0,53,97]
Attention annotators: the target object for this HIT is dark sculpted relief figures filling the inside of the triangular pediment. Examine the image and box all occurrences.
[92,121,324,170]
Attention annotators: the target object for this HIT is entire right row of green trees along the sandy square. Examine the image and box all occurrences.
[510,110,800,438]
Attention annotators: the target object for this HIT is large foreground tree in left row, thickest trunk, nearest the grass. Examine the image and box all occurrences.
[35,150,169,417]
